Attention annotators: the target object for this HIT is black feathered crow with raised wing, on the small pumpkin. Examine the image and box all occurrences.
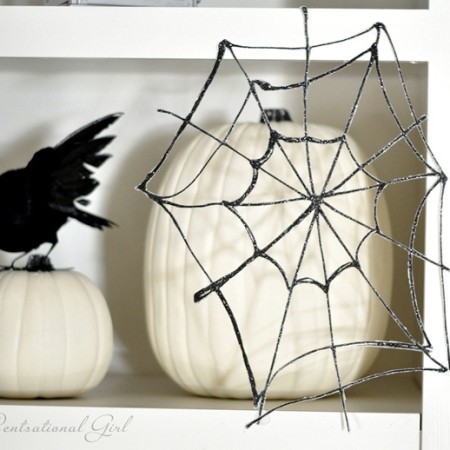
[0,113,122,252]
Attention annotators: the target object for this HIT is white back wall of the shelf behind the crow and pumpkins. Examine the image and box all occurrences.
[0,51,426,371]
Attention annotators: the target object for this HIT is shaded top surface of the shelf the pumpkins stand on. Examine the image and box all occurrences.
[0,374,421,414]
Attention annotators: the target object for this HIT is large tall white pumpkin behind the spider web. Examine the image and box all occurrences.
[145,121,393,398]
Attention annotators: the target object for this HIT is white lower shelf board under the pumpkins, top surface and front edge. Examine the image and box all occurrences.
[0,375,420,450]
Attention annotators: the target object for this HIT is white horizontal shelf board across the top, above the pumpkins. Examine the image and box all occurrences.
[0,6,445,61]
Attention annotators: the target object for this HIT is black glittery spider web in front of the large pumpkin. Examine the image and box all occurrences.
[138,8,450,429]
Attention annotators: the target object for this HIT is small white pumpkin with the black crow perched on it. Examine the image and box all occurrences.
[0,270,113,398]
